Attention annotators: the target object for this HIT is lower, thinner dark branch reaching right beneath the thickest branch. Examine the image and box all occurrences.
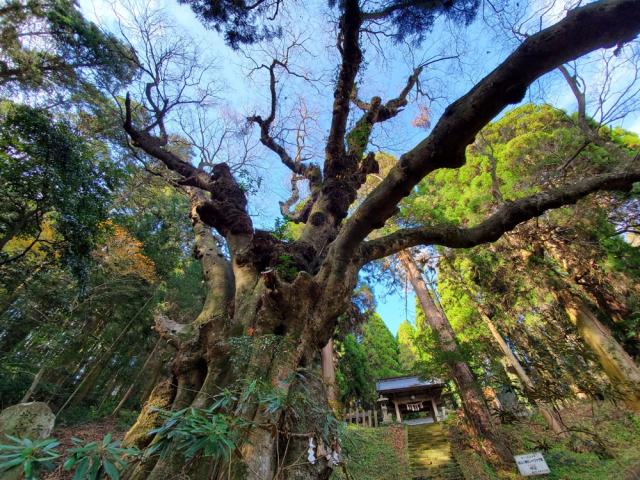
[360,167,640,264]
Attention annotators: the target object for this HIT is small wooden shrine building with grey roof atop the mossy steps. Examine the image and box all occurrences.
[376,376,446,424]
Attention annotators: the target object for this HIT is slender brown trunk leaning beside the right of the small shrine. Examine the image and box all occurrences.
[398,251,513,462]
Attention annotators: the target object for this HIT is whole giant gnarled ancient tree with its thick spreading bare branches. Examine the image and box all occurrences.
[124,0,640,479]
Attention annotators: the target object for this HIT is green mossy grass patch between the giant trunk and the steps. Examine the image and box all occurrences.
[332,426,411,480]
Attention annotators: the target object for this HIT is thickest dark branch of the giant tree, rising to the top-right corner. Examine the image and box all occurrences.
[332,0,640,261]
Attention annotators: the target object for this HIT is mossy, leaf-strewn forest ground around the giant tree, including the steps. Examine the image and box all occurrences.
[30,402,640,480]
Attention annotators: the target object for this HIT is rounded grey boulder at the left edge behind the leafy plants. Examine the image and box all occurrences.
[0,402,56,443]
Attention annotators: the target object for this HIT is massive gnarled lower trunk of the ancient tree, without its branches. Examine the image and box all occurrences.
[125,191,338,480]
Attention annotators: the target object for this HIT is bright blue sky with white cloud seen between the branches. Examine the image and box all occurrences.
[80,0,640,333]
